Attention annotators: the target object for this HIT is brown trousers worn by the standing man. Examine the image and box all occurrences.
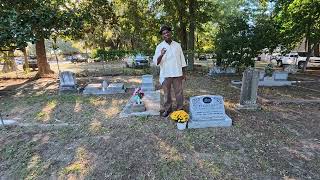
[162,76,183,111]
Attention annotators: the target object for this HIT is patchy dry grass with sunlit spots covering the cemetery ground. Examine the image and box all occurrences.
[0,64,320,179]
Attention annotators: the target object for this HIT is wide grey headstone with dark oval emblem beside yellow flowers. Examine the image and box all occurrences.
[188,95,232,128]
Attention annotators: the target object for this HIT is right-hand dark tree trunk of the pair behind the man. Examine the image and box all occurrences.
[188,0,196,70]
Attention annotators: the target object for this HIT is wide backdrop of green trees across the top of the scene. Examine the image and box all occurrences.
[0,0,320,75]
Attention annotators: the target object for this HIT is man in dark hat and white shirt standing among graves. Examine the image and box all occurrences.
[153,26,187,117]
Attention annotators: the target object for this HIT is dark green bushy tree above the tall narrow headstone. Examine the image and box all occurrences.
[215,1,282,70]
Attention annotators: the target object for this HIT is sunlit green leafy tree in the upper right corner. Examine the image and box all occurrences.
[274,0,320,70]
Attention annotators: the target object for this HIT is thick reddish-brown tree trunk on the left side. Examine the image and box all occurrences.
[36,38,54,78]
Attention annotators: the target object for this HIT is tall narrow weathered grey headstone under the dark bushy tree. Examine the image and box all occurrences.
[237,68,259,109]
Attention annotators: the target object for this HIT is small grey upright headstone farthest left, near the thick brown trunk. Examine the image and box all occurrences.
[59,71,77,91]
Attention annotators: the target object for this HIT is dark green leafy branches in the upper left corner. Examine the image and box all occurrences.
[0,0,81,48]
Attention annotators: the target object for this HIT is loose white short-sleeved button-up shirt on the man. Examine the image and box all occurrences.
[153,41,187,84]
